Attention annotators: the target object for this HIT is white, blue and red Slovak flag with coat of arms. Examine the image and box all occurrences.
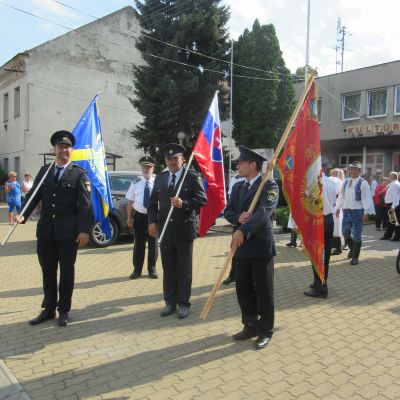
[193,92,226,236]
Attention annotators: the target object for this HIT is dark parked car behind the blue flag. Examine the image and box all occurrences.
[90,171,142,247]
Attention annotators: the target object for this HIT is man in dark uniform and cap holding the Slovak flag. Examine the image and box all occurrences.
[148,143,207,318]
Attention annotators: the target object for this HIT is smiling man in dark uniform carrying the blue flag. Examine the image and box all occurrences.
[17,131,92,326]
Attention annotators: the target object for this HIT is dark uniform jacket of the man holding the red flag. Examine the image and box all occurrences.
[224,177,279,258]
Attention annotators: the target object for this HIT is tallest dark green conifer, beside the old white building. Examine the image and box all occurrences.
[131,0,230,162]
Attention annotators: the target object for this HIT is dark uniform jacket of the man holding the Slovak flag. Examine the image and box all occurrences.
[147,169,207,241]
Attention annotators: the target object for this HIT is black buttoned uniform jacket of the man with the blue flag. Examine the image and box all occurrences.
[24,163,92,240]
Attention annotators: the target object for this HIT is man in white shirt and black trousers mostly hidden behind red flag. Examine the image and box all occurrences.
[304,174,336,298]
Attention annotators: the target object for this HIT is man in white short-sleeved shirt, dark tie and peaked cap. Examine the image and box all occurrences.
[125,156,158,279]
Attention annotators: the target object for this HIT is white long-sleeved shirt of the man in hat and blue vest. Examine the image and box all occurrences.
[336,177,375,214]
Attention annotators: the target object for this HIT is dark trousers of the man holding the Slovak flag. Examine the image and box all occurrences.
[160,239,193,307]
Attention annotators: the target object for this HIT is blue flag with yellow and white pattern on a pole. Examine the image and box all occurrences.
[71,96,113,239]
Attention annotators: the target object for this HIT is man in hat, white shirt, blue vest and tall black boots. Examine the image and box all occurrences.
[336,161,375,265]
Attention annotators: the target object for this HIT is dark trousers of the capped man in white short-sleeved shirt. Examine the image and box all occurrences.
[132,211,158,275]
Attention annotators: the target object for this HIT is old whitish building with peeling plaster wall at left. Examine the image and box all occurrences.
[0,7,143,177]
